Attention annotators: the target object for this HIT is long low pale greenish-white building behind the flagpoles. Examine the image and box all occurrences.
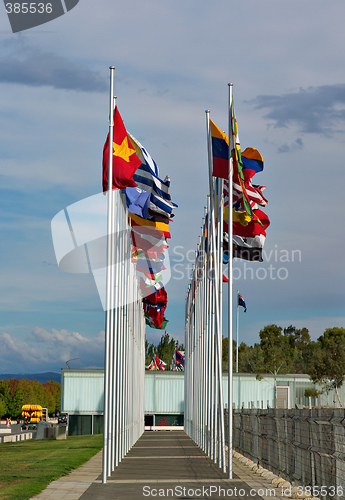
[61,369,345,435]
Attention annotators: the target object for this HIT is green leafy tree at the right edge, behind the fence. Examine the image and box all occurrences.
[308,327,345,406]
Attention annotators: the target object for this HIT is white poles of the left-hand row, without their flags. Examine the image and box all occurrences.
[102,67,145,483]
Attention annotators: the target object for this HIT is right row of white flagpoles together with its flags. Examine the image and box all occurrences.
[185,84,270,479]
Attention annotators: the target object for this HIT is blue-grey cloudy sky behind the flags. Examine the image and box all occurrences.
[0,0,345,373]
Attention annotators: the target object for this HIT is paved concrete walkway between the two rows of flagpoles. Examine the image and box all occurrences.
[30,431,286,500]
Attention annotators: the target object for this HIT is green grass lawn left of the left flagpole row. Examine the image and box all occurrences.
[0,434,103,500]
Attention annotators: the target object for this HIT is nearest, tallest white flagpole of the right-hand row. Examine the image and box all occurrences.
[228,83,234,479]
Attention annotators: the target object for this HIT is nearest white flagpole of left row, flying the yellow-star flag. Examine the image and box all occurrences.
[102,66,115,483]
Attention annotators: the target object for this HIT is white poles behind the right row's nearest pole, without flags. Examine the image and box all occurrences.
[184,190,226,471]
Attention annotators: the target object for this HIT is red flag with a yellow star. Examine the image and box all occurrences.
[103,107,141,192]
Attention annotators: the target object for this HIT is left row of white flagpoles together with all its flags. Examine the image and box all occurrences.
[102,67,177,483]
